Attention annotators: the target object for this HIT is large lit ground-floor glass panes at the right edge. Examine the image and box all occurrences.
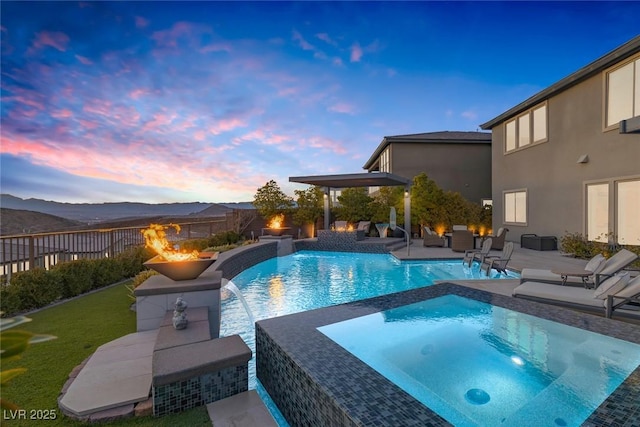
[585,178,640,246]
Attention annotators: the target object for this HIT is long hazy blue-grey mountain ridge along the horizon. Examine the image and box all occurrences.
[0,194,229,223]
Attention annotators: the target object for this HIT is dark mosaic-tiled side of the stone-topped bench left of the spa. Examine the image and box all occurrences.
[152,364,249,417]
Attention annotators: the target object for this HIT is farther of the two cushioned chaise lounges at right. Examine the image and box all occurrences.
[520,248,638,287]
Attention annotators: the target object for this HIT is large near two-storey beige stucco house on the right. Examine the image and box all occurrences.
[481,36,640,245]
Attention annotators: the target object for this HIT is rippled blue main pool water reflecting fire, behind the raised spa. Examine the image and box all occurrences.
[220,251,519,425]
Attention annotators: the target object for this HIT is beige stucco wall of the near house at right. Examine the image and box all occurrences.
[492,69,640,242]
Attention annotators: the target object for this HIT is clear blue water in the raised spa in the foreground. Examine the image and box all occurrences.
[318,295,640,426]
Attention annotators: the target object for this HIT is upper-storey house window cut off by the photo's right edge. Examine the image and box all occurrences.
[605,58,640,128]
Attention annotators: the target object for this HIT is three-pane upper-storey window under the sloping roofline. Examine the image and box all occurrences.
[505,104,547,152]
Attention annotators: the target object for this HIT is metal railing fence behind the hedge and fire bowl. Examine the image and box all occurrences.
[0,216,233,279]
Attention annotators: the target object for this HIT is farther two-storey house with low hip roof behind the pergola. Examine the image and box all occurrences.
[363,131,492,203]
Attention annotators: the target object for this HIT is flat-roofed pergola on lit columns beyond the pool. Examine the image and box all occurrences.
[289,172,411,233]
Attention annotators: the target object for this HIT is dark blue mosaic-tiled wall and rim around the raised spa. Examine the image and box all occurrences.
[256,282,640,427]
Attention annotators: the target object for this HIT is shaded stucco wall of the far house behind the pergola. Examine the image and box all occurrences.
[391,143,491,203]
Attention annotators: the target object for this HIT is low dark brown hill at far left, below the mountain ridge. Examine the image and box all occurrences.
[0,208,84,236]
